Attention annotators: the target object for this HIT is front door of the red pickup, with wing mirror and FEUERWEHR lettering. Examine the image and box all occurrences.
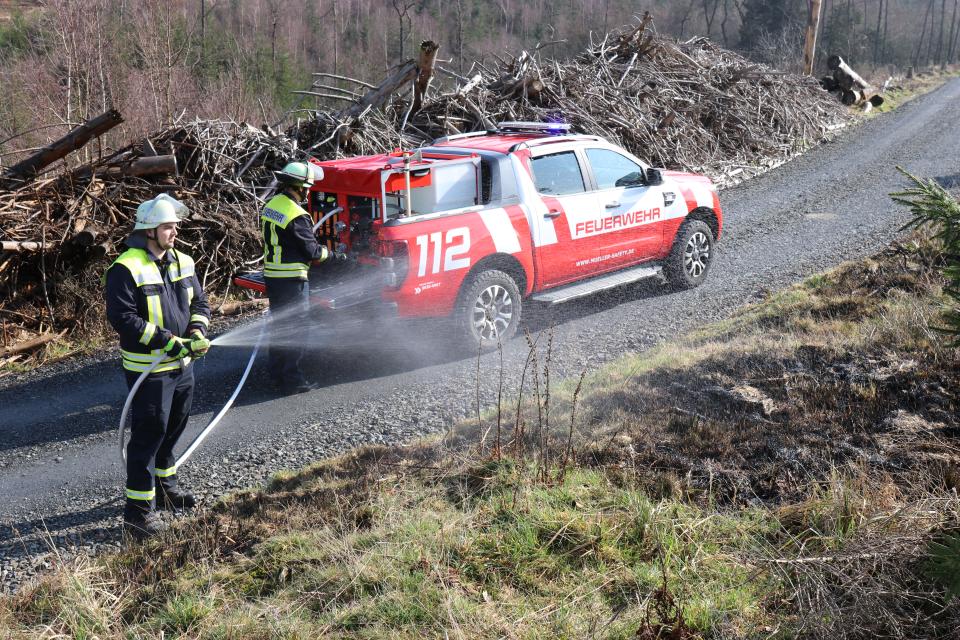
[572,147,664,271]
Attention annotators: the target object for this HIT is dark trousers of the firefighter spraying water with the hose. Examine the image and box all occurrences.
[124,365,193,501]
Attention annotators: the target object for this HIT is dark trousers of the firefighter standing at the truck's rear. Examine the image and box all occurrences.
[264,278,310,387]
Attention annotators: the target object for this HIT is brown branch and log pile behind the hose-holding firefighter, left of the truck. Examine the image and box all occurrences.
[0,121,296,362]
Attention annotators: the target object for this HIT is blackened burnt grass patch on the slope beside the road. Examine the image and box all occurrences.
[578,242,960,504]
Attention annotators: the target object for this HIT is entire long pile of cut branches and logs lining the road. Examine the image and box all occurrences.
[0,16,850,366]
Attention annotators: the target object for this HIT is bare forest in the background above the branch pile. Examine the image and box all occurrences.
[0,0,960,166]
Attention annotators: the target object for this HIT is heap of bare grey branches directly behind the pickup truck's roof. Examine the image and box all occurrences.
[296,16,851,185]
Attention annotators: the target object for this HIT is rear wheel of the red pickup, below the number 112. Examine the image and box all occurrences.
[453,269,523,352]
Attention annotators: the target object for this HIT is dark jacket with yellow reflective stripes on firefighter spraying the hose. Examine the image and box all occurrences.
[105,245,210,373]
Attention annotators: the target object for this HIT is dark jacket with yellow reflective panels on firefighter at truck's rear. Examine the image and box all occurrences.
[260,194,330,280]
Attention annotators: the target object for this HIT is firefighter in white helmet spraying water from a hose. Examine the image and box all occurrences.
[105,194,210,539]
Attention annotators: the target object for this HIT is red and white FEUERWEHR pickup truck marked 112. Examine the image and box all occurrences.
[235,122,723,349]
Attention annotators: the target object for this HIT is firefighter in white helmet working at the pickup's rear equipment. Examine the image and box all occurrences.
[260,162,346,393]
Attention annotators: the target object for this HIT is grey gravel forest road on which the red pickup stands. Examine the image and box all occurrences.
[0,79,960,592]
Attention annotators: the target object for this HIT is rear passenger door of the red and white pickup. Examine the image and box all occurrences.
[528,149,602,288]
